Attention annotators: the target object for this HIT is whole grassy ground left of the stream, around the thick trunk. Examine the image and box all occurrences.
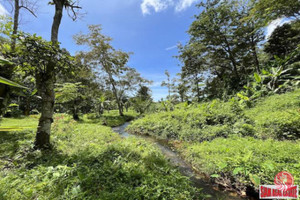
[0,115,201,200]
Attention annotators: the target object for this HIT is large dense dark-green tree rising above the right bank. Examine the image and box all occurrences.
[179,0,263,101]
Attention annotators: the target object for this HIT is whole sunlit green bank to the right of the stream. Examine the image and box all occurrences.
[128,90,300,193]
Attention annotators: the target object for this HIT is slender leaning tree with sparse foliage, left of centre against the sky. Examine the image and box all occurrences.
[74,25,146,116]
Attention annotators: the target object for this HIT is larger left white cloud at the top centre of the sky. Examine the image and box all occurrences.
[141,0,173,15]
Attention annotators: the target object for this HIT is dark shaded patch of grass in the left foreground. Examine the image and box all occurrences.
[0,141,190,199]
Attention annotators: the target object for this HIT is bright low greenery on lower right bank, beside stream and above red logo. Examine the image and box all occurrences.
[177,136,300,191]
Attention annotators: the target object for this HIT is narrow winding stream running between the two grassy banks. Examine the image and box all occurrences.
[113,122,255,200]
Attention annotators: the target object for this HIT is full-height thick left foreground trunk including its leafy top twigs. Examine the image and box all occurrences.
[29,0,80,149]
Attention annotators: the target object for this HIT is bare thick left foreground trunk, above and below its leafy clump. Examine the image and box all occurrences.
[35,0,65,149]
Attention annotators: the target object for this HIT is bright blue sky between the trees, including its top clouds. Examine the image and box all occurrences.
[0,0,204,100]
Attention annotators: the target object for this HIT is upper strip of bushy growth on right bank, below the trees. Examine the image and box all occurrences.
[128,90,300,142]
